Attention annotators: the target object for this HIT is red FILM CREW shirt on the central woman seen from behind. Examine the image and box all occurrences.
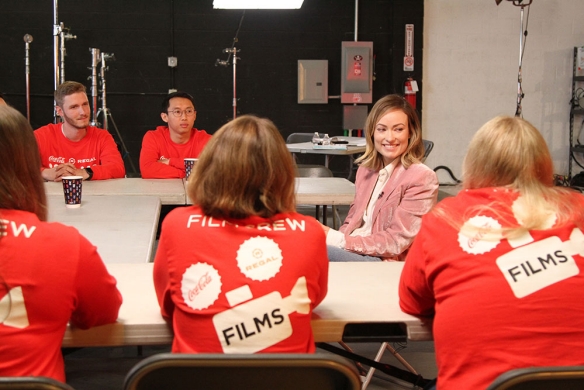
[154,206,329,353]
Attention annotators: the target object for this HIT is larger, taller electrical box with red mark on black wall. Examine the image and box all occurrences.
[341,41,373,104]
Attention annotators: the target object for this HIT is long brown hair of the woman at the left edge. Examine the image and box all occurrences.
[0,106,47,221]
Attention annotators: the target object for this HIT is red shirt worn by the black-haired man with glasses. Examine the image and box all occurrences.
[140,126,211,179]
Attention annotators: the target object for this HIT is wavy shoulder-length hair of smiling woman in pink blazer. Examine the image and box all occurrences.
[355,95,424,170]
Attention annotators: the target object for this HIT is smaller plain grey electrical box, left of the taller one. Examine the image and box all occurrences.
[298,60,328,104]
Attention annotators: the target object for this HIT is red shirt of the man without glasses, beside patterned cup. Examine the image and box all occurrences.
[34,123,126,180]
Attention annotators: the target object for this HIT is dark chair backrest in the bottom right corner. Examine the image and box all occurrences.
[487,366,584,390]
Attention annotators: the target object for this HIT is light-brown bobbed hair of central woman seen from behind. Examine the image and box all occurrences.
[188,115,296,218]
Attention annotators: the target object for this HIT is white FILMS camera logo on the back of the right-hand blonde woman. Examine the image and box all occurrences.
[497,228,584,298]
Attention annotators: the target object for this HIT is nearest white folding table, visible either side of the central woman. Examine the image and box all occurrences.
[63,262,432,347]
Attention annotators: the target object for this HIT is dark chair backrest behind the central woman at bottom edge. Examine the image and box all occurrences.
[124,353,361,390]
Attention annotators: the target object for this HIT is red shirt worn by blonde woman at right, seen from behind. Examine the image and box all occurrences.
[399,188,584,389]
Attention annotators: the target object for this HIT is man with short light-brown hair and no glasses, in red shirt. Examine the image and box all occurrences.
[34,81,126,181]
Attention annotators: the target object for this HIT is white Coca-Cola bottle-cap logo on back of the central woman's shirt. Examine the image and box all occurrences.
[181,263,222,310]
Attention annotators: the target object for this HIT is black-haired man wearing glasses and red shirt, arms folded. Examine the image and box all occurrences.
[140,91,211,179]
